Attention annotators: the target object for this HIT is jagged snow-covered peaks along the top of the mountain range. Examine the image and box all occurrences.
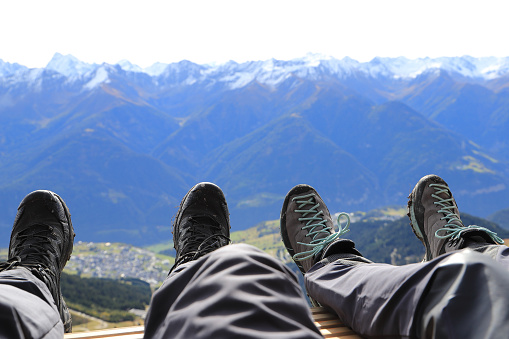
[0,53,509,89]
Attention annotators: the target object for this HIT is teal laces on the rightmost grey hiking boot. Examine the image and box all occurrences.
[429,184,504,244]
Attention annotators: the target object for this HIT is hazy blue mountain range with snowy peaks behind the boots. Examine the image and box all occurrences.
[0,54,509,246]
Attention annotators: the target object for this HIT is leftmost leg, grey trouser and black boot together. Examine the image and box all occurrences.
[0,191,74,338]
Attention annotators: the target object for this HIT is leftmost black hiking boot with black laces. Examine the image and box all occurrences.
[0,191,75,332]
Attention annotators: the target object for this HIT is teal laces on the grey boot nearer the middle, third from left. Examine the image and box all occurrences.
[292,193,350,261]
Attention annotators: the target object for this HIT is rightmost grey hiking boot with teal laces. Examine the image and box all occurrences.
[408,174,503,261]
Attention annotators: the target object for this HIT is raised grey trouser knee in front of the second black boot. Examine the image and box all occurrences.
[145,245,321,339]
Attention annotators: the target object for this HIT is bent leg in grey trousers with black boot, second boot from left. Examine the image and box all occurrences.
[145,183,321,339]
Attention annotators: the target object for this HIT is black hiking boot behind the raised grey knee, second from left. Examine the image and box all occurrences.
[170,182,230,273]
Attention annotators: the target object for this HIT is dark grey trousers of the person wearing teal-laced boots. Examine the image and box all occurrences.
[305,246,509,338]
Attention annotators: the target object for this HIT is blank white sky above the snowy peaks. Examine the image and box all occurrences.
[0,0,509,67]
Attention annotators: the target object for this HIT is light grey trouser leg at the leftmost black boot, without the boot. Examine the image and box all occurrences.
[0,268,64,339]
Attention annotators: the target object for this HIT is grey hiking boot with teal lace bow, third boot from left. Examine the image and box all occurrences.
[281,185,354,274]
